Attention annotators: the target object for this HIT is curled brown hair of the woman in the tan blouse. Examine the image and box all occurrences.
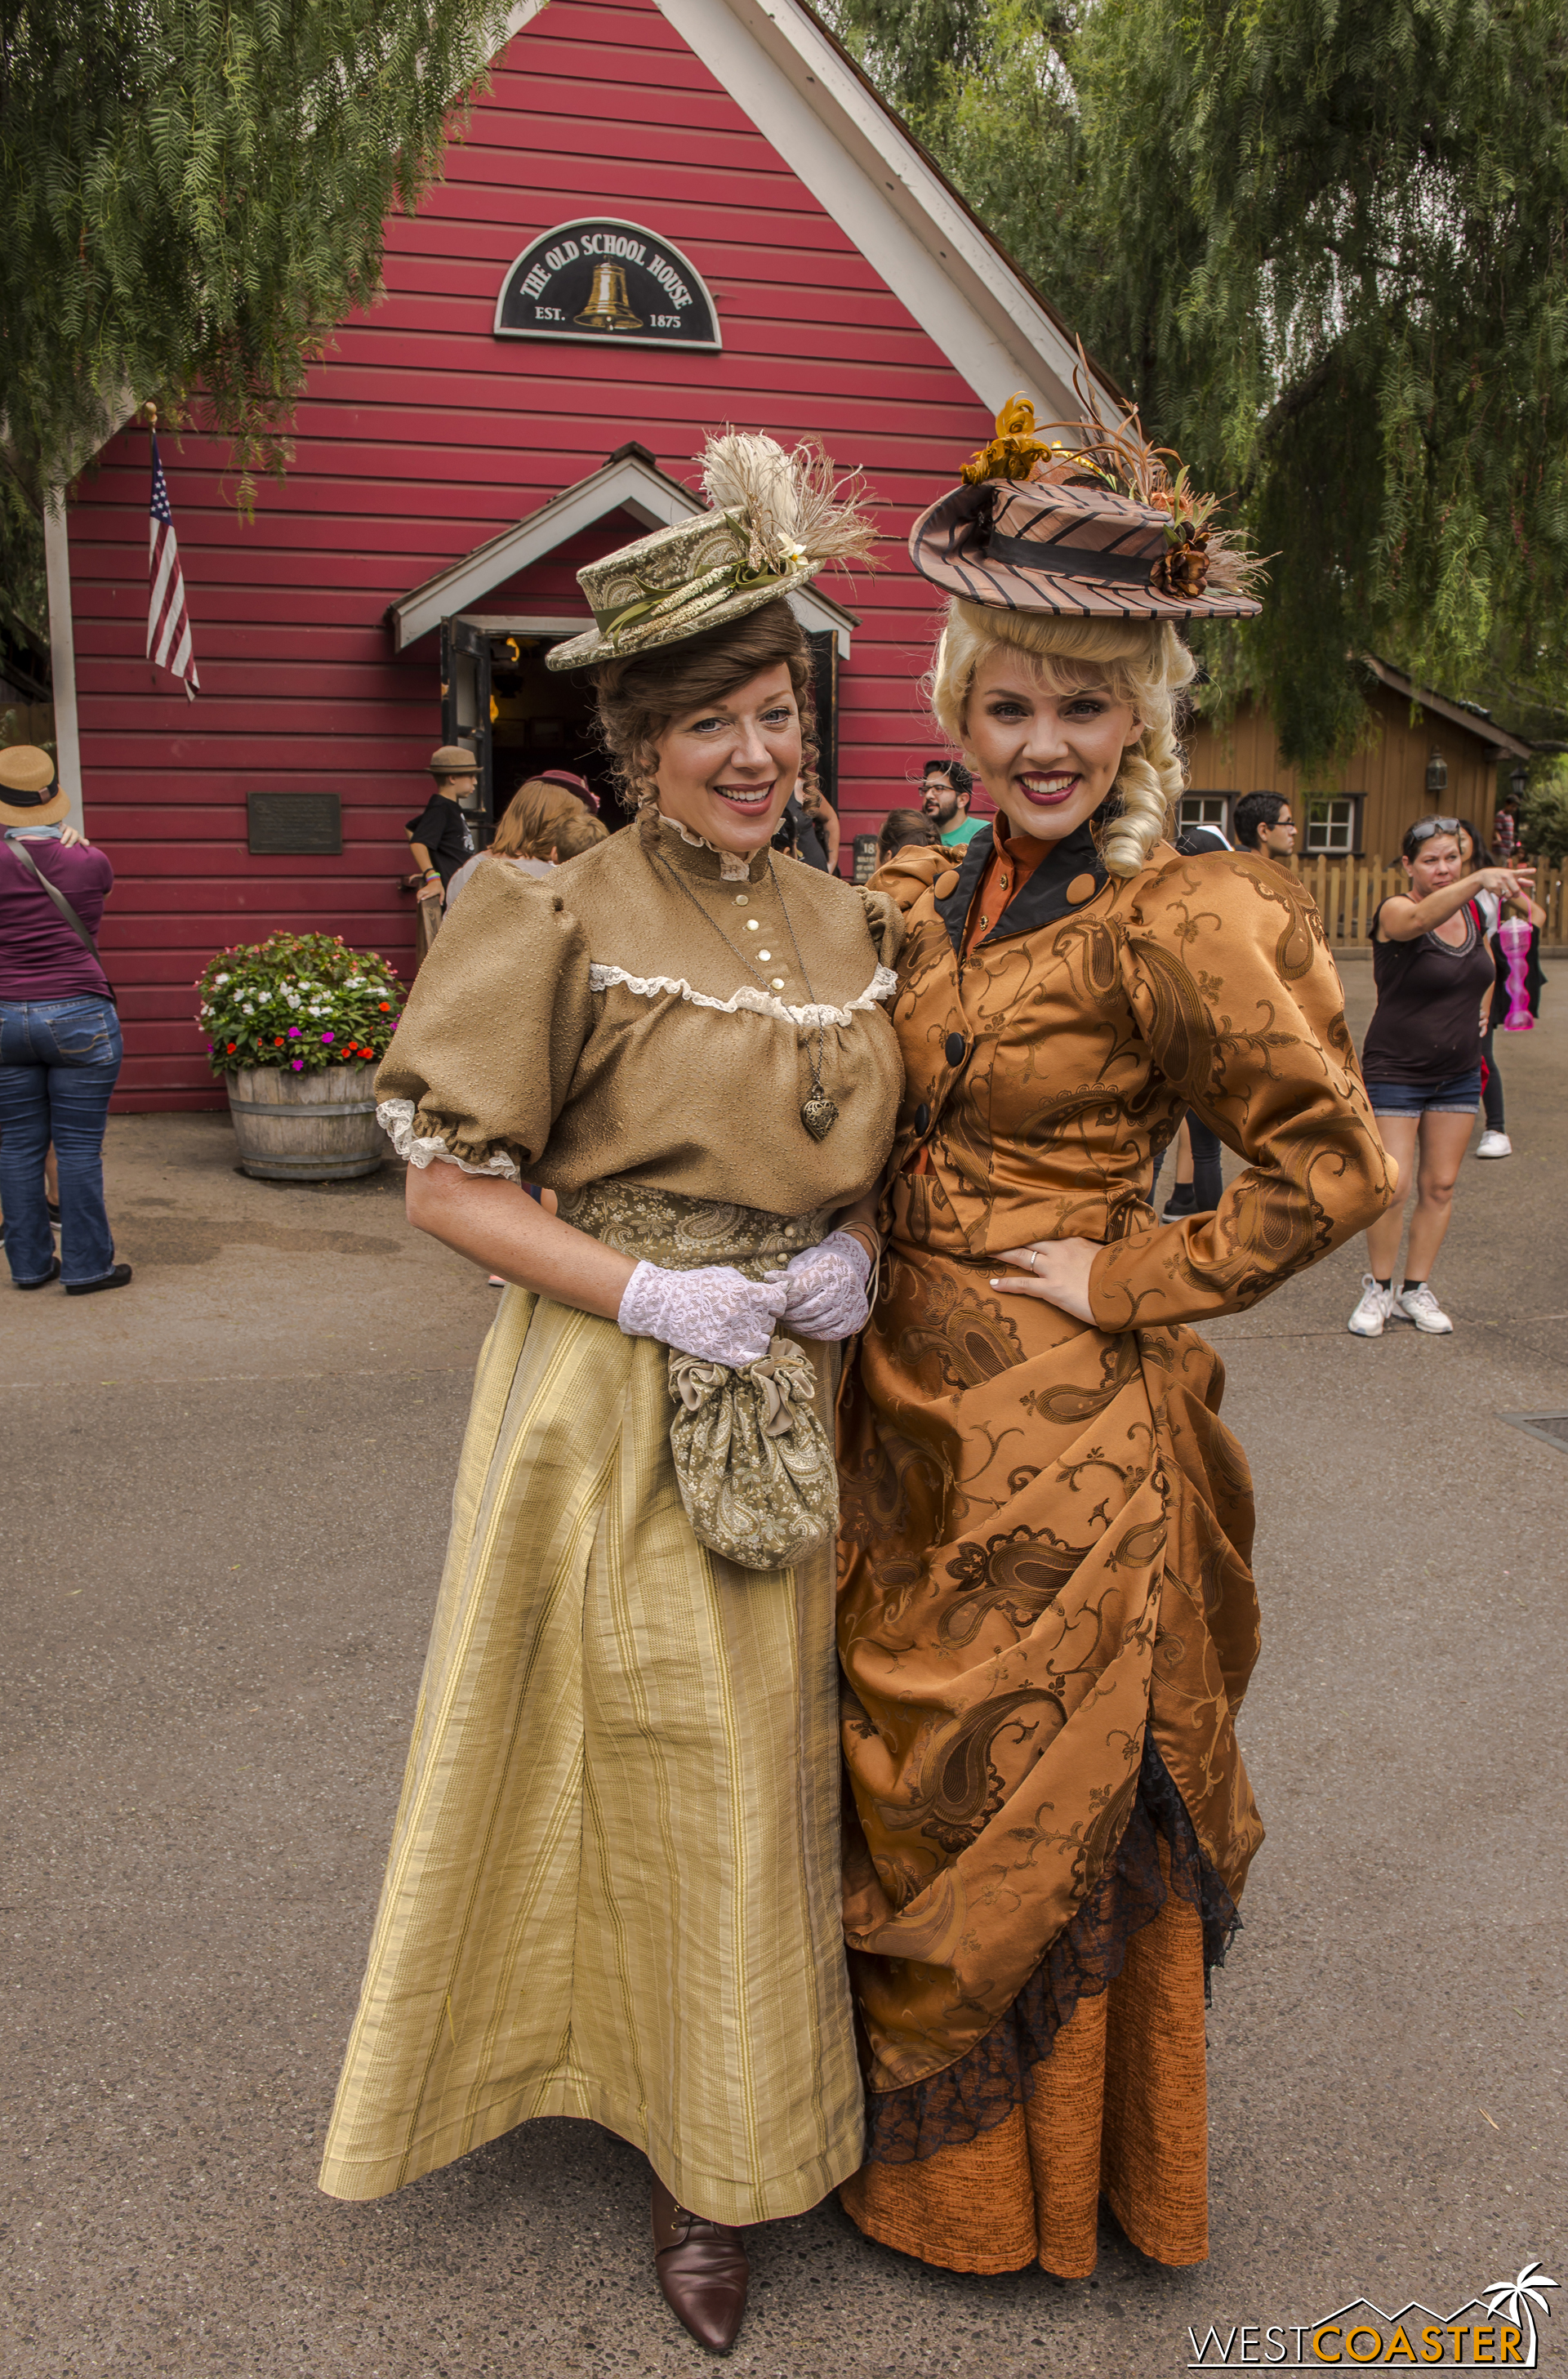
[595,595,816,842]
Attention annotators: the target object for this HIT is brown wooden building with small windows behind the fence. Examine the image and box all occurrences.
[1183,654,1530,862]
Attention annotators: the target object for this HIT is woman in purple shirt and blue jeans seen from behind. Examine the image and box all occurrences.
[0,745,131,1297]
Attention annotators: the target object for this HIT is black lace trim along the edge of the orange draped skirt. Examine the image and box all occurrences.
[866,1732,1242,2165]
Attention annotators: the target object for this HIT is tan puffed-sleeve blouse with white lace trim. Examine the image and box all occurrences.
[376,821,904,1216]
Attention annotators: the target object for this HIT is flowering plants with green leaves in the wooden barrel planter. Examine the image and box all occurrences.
[198,933,402,1076]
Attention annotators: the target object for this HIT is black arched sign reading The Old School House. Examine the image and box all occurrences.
[495,216,721,352]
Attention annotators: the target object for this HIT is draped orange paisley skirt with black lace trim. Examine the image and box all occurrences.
[840,1232,1261,2279]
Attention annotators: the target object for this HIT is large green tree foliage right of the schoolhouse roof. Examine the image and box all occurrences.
[835,0,1568,764]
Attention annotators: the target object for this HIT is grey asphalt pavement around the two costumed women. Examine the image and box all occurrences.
[0,964,1568,2379]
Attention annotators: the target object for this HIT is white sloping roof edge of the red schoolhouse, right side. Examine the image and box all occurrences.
[507,0,1123,421]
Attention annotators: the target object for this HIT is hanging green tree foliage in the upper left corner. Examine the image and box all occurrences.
[0,0,507,623]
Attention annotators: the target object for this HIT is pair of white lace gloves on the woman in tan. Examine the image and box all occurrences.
[617,1230,871,1368]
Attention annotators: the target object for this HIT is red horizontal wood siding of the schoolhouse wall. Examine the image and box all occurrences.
[69,0,987,1108]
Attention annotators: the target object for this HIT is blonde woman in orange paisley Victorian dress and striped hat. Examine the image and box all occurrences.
[840,409,1394,2277]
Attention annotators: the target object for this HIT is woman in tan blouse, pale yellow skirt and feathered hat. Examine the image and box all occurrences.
[321,433,902,2353]
